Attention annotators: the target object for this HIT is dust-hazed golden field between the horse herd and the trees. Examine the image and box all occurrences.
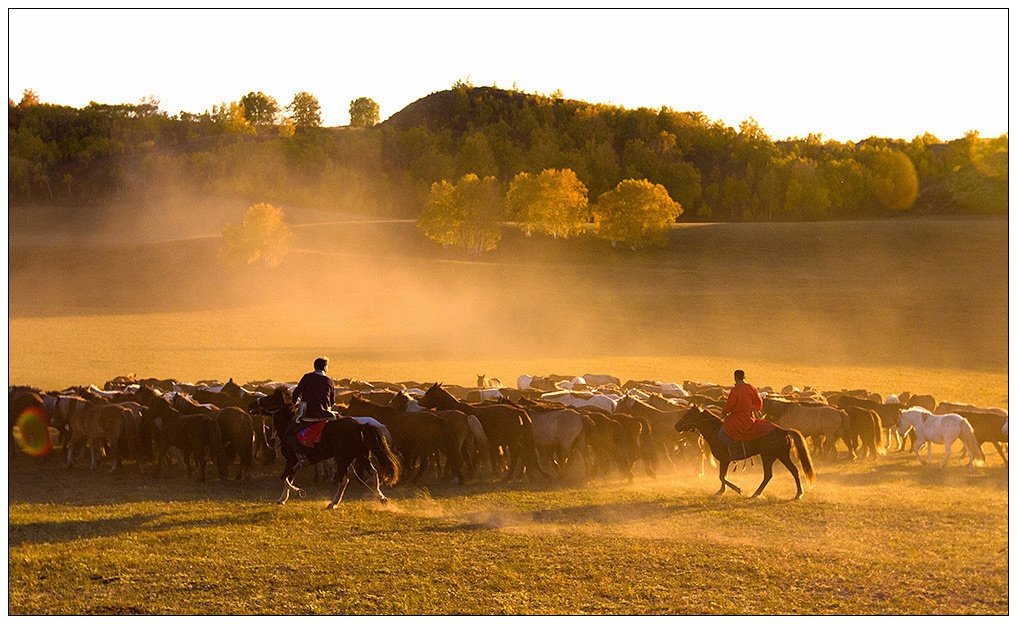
[8,185,1008,400]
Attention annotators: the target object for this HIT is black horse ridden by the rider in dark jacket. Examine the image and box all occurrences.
[273,403,399,509]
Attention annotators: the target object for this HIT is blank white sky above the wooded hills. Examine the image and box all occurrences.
[7,8,1009,140]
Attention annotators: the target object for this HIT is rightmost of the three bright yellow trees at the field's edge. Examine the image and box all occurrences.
[593,180,681,249]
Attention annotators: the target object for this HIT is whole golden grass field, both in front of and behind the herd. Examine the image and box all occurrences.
[8,209,1009,615]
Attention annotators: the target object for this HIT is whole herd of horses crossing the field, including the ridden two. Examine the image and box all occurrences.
[9,375,1009,507]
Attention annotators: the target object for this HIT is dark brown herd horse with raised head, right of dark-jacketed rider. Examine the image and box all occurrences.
[417,383,548,482]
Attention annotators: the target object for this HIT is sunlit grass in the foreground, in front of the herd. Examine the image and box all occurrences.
[8,445,1009,615]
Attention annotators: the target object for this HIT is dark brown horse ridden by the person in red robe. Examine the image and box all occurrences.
[674,407,816,500]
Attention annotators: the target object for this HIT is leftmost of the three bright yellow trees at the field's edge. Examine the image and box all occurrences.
[417,174,502,255]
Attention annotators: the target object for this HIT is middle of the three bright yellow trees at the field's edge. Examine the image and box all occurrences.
[505,169,589,238]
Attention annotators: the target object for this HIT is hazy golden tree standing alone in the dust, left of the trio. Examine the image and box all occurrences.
[219,203,293,267]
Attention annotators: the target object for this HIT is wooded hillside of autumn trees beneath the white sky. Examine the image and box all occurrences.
[8,81,1009,250]
